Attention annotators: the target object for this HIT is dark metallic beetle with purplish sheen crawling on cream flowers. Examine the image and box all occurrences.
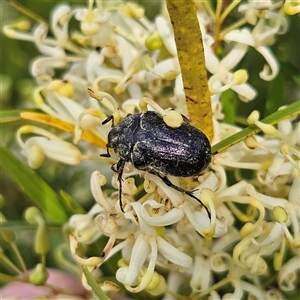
[101,111,211,216]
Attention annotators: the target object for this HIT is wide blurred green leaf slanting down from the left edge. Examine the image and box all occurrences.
[0,146,68,224]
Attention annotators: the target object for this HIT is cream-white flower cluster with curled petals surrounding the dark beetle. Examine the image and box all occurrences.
[4,0,300,299]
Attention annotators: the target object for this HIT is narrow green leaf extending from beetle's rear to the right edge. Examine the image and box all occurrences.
[212,101,300,153]
